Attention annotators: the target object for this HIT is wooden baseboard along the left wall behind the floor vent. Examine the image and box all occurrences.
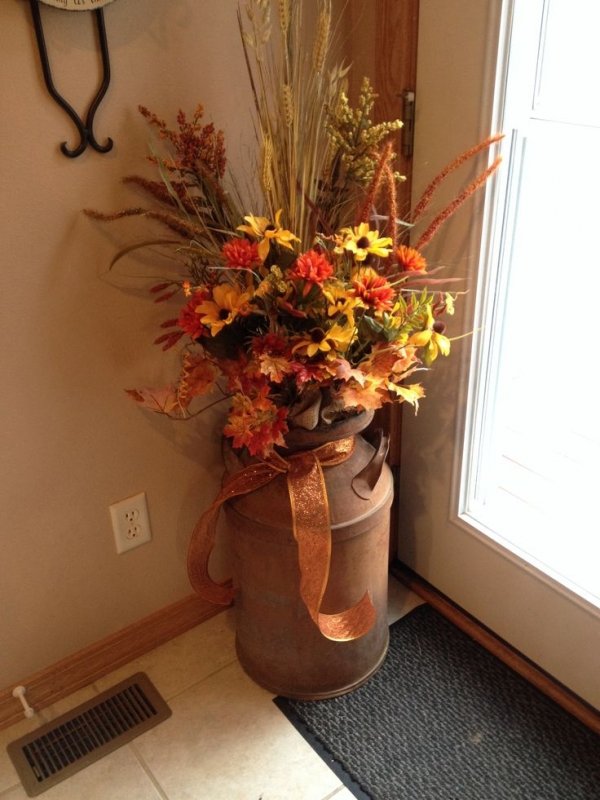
[0,595,224,730]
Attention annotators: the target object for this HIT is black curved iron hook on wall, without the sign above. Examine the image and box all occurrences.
[30,0,113,158]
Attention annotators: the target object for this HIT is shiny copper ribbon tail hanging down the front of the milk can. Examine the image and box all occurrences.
[287,448,376,641]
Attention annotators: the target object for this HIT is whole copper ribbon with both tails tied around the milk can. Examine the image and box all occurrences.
[188,436,375,641]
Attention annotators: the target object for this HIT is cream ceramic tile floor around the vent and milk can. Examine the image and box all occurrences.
[0,579,421,800]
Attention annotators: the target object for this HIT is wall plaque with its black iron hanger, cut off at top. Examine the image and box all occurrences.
[29,0,114,158]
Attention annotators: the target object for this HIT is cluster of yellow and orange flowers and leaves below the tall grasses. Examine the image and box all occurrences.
[130,203,453,457]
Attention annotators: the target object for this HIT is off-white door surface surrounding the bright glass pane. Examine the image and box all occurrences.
[399,0,600,707]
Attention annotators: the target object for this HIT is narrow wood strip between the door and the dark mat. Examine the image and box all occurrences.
[390,561,600,733]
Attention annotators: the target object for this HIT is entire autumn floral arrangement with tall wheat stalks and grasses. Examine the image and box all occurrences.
[87,0,499,458]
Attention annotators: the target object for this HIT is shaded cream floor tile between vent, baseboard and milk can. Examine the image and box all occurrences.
[95,609,236,700]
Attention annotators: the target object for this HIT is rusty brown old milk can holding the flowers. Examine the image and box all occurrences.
[225,413,393,699]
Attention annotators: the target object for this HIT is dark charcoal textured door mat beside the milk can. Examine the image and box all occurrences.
[275,605,600,800]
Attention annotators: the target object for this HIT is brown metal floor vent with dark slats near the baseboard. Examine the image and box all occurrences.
[7,672,171,797]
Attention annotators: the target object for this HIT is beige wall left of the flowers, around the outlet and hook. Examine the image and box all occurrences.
[0,0,255,687]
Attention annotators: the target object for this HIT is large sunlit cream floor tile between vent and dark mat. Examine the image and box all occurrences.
[135,662,341,800]
